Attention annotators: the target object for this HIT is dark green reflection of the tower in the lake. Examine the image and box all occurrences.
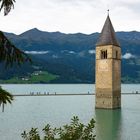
[95,109,121,140]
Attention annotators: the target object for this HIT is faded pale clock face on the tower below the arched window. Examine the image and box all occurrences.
[98,60,109,71]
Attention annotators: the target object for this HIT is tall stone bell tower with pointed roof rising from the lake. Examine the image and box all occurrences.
[95,15,121,109]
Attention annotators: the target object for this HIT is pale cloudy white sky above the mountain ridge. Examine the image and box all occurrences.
[0,0,140,34]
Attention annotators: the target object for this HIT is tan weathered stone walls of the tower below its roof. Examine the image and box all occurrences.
[96,45,121,109]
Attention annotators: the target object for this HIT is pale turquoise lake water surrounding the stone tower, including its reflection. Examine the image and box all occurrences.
[0,84,140,140]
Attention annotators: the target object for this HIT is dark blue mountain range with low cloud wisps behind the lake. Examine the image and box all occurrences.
[0,28,140,83]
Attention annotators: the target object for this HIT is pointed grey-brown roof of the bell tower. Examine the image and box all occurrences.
[96,15,120,47]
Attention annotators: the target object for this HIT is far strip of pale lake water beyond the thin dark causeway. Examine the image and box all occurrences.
[1,84,140,94]
